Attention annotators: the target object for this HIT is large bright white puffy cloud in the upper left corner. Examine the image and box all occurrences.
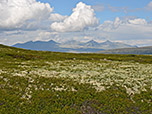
[0,0,53,29]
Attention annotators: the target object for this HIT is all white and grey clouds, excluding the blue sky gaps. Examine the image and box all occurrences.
[0,0,152,45]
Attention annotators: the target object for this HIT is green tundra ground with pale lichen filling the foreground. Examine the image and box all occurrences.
[0,45,152,114]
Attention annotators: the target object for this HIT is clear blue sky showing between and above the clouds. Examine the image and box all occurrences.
[39,0,152,23]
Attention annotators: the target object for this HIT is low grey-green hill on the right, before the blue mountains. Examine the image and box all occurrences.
[99,46,152,55]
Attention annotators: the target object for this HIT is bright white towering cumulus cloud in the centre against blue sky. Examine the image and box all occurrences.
[51,2,99,32]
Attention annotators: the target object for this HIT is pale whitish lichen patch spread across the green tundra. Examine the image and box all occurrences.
[8,59,152,95]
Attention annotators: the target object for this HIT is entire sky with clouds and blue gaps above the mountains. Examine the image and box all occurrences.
[0,0,152,46]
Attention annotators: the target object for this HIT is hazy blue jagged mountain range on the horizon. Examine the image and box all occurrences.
[13,40,137,53]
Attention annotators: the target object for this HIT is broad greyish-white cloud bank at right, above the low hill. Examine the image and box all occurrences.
[94,17,152,45]
